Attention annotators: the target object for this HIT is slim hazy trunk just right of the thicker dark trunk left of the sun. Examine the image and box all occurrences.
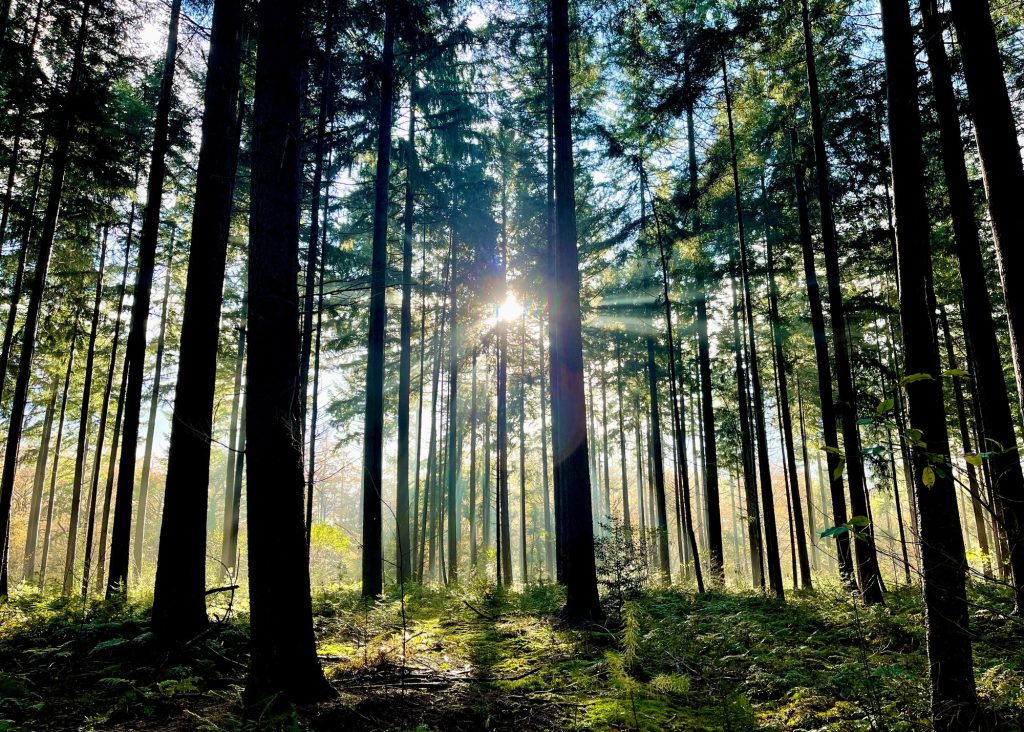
[395,78,417,582]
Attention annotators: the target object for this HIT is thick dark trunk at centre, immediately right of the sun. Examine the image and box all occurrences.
[551,0,601,619]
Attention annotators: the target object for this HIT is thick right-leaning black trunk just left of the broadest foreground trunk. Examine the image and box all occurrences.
[153,0,244,640]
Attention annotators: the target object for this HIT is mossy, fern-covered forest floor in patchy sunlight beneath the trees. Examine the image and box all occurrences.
[0,585,1024,732]
